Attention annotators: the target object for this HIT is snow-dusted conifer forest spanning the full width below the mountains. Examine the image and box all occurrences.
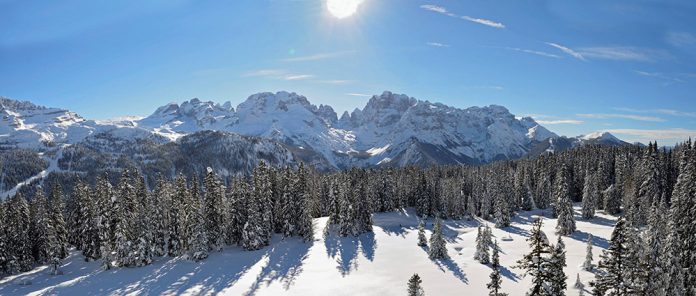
[0,141,696,295]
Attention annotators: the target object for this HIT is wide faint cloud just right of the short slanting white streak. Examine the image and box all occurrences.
[577,46,669,62]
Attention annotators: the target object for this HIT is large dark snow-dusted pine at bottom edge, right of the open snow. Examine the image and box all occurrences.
[590,218,630,295]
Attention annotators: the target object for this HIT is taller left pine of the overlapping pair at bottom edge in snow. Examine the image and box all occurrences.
[515,219,552,296]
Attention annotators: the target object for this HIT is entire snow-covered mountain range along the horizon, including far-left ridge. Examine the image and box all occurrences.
[0,91,624,170]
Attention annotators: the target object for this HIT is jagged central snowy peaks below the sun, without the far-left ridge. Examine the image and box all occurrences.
[137,92,557,168]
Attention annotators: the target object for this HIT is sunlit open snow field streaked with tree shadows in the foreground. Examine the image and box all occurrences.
[0,207,616,296]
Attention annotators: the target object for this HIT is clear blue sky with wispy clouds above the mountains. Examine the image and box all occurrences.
[0,0,696,144]
